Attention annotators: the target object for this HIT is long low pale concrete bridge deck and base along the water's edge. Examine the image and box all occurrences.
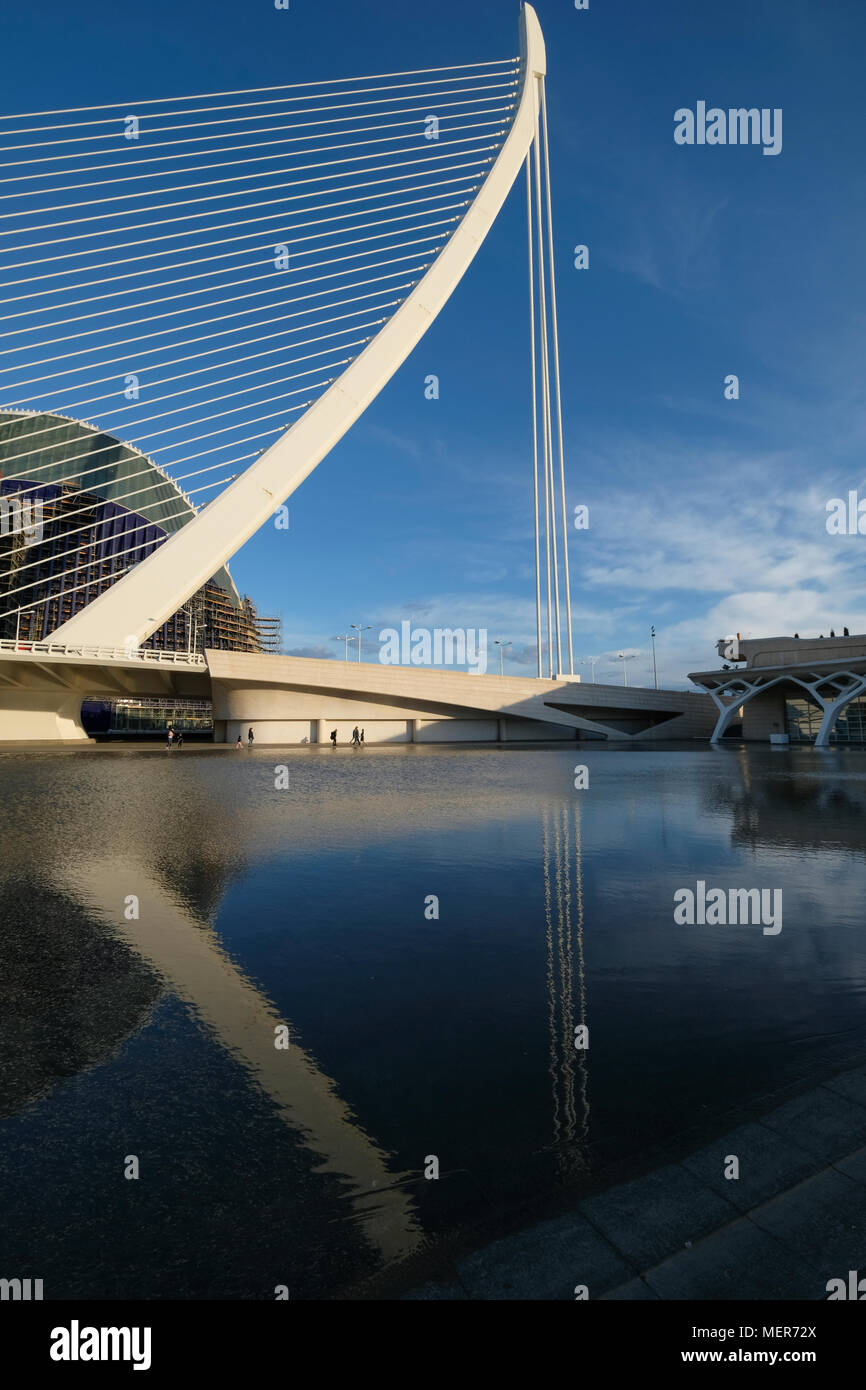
[0,644,713,746]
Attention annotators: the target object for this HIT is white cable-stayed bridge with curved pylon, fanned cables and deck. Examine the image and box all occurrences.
[0,6,717,741]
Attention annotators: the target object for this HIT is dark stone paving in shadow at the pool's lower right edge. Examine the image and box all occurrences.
[405,1068,866,1301]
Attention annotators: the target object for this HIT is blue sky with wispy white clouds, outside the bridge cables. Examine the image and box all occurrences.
[3,0,866,685]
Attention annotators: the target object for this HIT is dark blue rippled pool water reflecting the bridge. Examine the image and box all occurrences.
[0,745,866,1298]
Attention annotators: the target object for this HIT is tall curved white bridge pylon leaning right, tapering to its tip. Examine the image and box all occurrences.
[56,4,546,646]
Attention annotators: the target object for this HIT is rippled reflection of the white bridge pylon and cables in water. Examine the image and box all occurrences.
[4,751,606,1289]
